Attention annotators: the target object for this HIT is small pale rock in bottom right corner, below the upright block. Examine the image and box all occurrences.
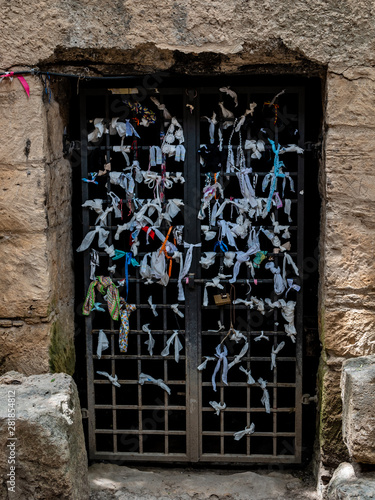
[325,463,375,500]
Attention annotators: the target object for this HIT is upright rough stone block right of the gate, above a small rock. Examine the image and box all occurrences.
[341,355,375,464]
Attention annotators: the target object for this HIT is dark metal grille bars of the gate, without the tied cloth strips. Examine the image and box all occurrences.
[81,84,304,463]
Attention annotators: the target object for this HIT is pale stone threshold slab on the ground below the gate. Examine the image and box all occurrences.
[89,464,319,500]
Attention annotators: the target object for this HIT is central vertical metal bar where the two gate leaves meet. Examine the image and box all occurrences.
[183,89,202,462]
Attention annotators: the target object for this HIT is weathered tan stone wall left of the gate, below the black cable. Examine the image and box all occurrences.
[0,78,74,375]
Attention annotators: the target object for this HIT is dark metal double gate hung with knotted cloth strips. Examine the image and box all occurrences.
[81,83,304,463]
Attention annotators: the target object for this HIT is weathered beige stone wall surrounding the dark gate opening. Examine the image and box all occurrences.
[0,0,375,476]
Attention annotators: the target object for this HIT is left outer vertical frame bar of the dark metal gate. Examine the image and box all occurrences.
[80,90,96,458]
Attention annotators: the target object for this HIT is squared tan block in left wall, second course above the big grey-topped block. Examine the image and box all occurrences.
[0,233,51,318]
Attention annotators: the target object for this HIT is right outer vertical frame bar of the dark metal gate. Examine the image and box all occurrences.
[295,88,306,461]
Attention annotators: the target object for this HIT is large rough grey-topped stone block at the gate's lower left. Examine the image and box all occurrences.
[0,371,89,500]
